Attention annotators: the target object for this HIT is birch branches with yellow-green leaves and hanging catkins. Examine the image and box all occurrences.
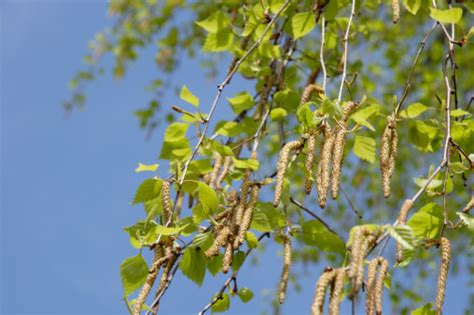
[65,0,474,314]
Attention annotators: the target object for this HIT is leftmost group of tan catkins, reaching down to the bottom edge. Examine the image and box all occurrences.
[133,180,180,315]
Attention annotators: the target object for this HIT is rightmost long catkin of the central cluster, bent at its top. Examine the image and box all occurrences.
[331,102,358,199]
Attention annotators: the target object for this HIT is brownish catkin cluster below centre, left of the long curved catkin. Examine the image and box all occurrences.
[204,155,260,273]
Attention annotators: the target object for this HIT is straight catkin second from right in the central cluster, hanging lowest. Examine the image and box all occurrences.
[316,123,334,208]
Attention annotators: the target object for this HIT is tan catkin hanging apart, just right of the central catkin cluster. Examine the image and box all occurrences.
[380,116,398,198]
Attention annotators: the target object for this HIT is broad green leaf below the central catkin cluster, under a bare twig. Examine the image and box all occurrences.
[302,220,346,254]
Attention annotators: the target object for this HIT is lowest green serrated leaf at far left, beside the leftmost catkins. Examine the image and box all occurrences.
[120,255,148,296]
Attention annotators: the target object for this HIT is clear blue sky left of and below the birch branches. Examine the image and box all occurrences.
[0,0,467,314]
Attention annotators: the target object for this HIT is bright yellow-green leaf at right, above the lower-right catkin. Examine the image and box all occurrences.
[408,202,443,239]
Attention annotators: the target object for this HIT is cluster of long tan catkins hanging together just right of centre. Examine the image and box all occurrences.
[273,84,358,208]
